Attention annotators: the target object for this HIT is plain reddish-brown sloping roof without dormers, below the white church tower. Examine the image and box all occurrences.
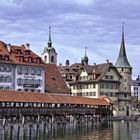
[45,64,70,94]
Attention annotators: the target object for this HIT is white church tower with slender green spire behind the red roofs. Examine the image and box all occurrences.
[42,27,57,64]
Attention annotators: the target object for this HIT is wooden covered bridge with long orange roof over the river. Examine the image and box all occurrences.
[0,91,112,124]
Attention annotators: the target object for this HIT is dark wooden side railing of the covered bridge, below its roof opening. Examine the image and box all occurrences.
[0,107,111,117]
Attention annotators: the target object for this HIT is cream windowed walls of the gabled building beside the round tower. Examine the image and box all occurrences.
[70,64,120,102]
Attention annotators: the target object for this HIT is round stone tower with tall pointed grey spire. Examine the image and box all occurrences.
[115,24,132,106]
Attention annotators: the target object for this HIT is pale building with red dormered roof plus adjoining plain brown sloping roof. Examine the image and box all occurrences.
[0,41,70,95]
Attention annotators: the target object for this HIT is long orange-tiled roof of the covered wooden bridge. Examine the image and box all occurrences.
[0,91,111,106]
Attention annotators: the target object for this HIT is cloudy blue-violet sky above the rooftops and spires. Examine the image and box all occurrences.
[0,0,140,78]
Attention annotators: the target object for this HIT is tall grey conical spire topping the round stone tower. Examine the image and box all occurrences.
[115,23,131,68]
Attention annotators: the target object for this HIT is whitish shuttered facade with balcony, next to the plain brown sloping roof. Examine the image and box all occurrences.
[15,65,45,93]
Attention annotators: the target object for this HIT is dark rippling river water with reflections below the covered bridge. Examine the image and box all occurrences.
[0,122,140,140]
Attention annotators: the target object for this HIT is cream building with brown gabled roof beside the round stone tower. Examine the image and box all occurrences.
[69,62,122,104]
